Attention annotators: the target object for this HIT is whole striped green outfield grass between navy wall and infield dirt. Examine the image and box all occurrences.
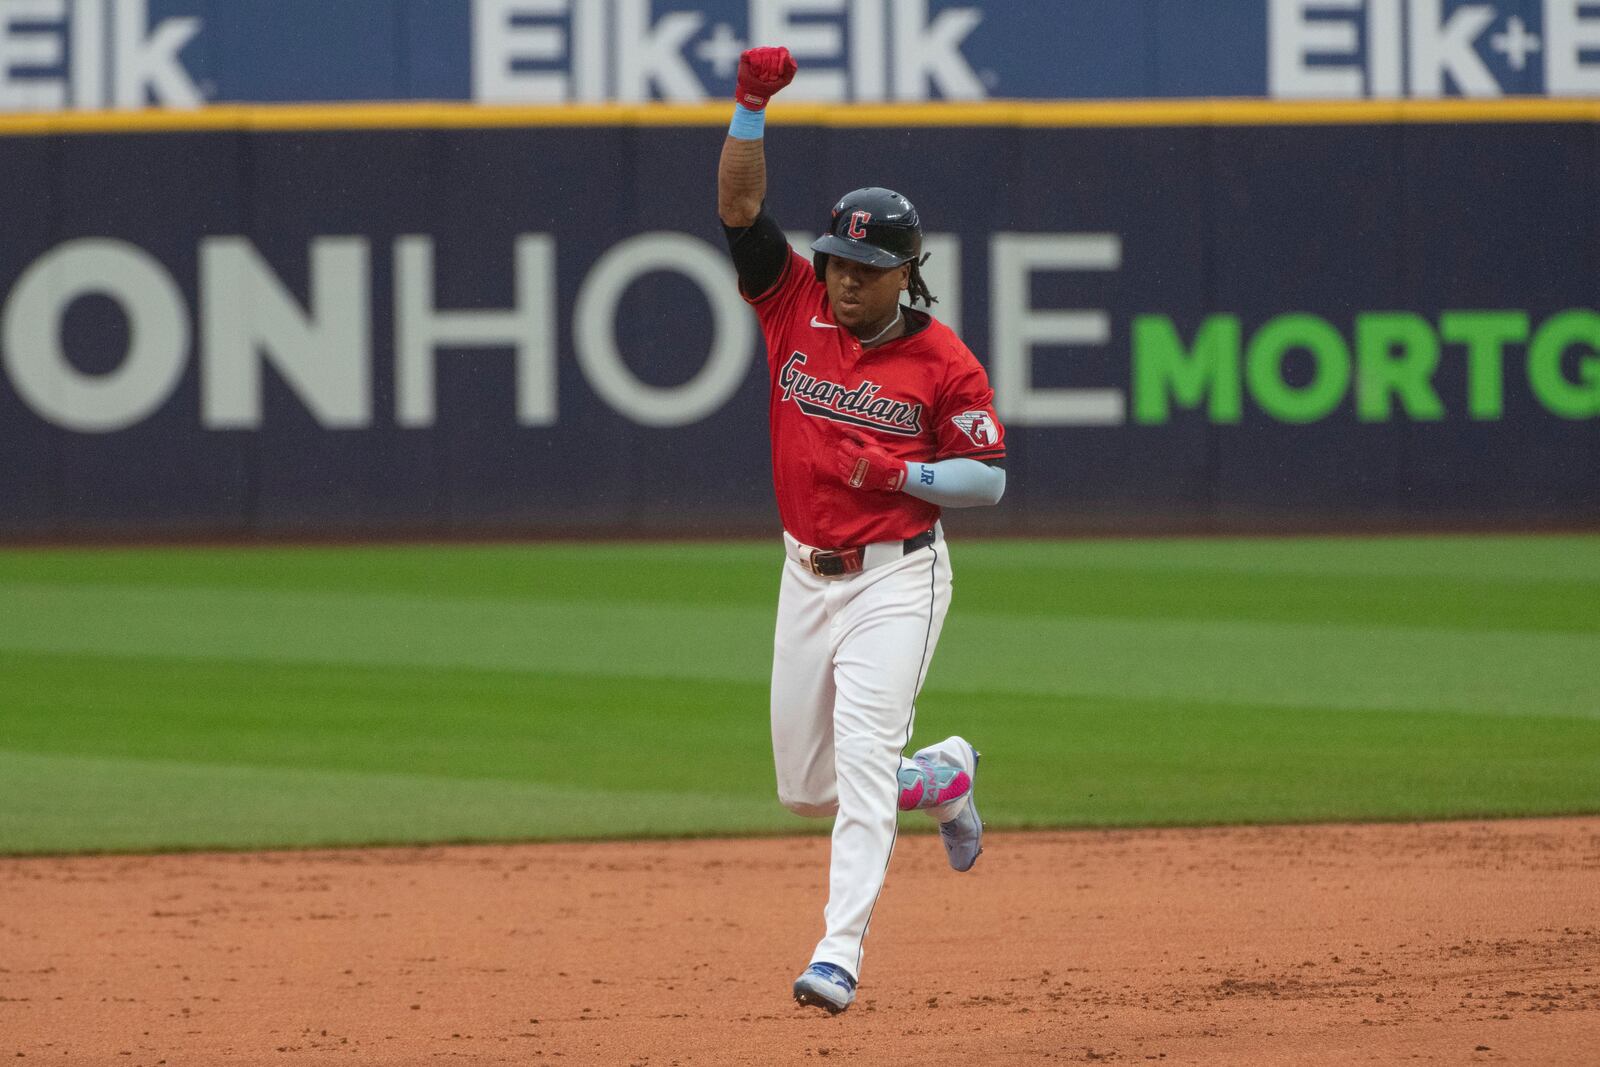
[0,536,1600,853]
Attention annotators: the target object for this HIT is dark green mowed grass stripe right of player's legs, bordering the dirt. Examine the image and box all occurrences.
[917,694,1600,827]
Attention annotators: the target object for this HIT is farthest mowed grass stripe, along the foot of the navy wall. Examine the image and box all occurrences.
[0,536,1600,633]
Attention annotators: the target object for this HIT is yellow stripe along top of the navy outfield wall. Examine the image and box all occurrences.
[0,96,1600,136]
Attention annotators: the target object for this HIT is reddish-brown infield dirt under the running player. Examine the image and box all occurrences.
[0,817,1600,1067]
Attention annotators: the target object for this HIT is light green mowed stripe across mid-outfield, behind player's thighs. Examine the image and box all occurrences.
[0,584,1600,717]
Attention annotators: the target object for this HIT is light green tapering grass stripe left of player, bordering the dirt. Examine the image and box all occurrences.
[0,750,795,854]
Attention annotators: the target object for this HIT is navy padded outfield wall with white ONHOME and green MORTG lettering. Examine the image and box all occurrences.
[0,101,1600,537]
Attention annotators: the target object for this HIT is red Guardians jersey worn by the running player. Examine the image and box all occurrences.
[746,250,1005,549]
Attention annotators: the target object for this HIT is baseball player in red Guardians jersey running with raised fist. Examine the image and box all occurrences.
[717,48,1005,1014]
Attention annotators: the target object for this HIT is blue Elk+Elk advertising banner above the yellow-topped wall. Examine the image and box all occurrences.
[0,0,1600,112]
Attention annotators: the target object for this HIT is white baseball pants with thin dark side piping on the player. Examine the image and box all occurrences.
[771,524,950,977]
